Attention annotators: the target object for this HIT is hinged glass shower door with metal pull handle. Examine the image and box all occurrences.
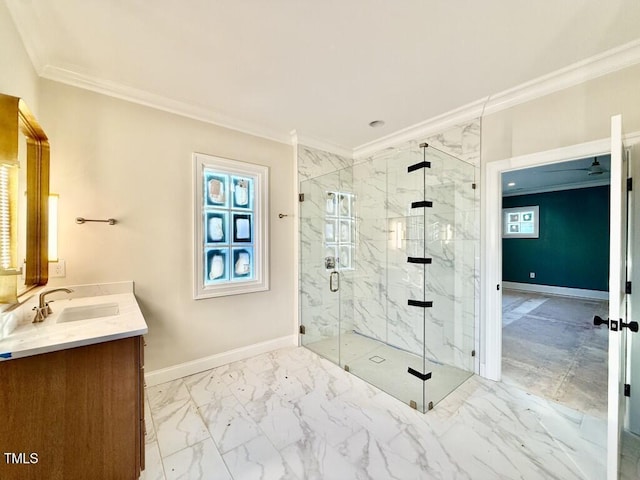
[300,169,355,364]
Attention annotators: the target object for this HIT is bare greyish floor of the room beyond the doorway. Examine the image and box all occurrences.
[502,290,608,418]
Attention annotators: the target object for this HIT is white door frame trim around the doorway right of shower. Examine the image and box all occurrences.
[479,134,616,381]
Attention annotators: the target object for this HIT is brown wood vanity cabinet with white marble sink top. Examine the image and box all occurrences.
[0,284,147,480]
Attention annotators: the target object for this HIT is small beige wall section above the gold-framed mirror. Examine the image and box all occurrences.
[0,2,38,110]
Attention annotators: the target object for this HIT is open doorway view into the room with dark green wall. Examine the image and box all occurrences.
[501,155,611,419]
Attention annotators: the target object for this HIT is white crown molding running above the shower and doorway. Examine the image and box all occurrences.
[353,40,640,158]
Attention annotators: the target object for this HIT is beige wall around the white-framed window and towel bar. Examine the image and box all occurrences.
[40,80,295,371]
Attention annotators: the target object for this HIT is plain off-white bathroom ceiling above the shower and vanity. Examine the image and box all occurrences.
[0,0,640,151]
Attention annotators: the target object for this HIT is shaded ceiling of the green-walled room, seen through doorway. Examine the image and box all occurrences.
[502,155,611,197]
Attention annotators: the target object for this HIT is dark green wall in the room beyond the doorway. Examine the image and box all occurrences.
[502,185,609,291]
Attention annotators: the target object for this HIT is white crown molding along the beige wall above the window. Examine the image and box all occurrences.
[40,65,291,145]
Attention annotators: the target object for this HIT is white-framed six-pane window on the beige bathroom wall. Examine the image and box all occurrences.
[193,153,269,300]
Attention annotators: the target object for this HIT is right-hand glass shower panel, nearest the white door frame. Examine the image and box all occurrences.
[418,147,476,409]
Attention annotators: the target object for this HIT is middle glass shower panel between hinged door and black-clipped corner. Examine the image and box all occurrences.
[341,152,423,408]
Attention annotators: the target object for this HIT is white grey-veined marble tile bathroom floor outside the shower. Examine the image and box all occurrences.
[142,347,640,480]
